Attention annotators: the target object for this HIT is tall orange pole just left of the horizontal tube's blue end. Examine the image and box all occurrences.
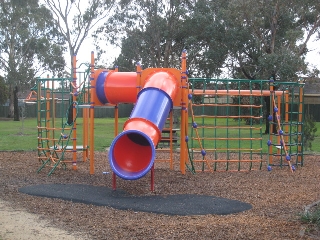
[90,52,95,174]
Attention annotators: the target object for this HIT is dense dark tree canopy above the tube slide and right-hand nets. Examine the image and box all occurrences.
[102,0,320,81]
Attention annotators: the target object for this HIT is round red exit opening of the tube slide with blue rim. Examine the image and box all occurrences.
[109,130,155,180]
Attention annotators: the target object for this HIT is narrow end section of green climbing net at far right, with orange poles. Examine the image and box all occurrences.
[267,81,304,172]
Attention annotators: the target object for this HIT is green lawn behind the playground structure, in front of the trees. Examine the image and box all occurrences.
[0,118,320,153]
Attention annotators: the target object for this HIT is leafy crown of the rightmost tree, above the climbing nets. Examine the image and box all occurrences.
[215,0,320,81]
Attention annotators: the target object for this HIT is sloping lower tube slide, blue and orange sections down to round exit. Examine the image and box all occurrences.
[109,87,173,180]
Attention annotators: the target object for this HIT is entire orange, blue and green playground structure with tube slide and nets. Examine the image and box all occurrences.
[29,51,304,188]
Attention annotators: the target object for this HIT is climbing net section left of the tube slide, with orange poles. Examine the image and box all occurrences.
[25,57,89,175]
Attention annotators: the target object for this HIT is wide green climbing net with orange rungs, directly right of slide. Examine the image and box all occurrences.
[189,79,264,171]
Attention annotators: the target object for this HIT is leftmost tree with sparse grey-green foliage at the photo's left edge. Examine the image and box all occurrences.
[0,0,64,119]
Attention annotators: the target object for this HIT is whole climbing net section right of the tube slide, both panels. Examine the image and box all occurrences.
[189,79,304,172]
